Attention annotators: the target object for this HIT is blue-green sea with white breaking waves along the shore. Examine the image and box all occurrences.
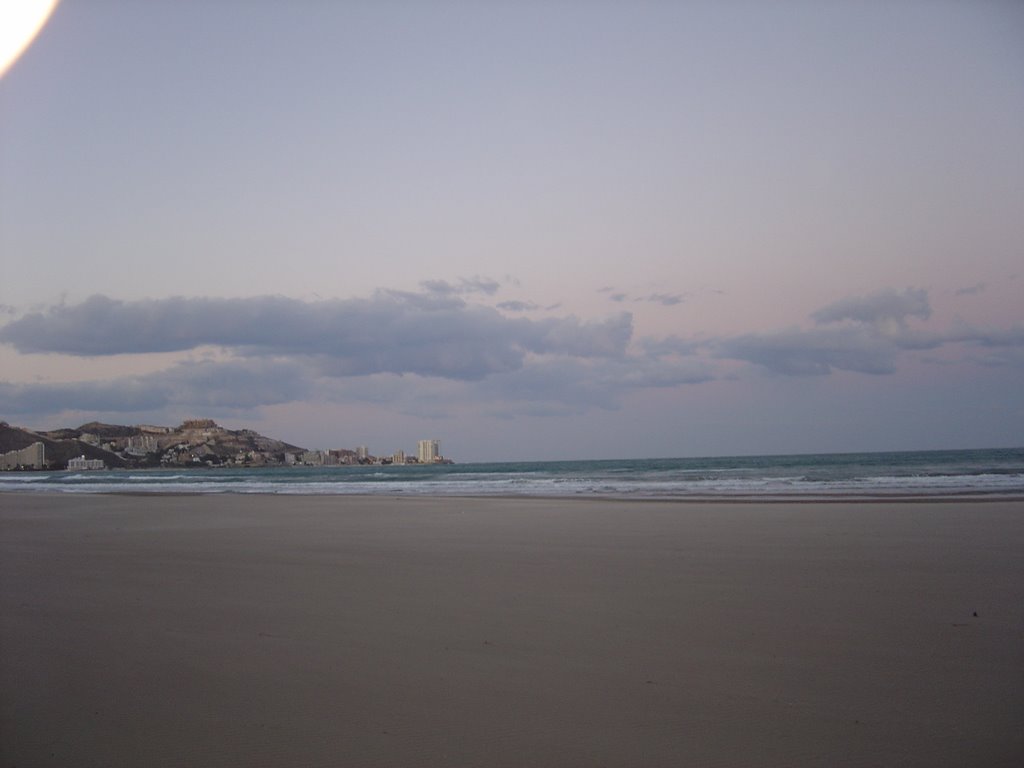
[0,447,1024,500]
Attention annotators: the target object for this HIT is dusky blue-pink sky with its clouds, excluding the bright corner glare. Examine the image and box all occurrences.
[0,0,1024,462]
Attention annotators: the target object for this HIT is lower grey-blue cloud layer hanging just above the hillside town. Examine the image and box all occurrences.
[0,342,713,423]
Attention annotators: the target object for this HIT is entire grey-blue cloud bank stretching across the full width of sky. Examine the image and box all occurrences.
[0,286,1024,413]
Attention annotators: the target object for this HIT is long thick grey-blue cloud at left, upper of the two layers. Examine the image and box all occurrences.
[0,291,633,380]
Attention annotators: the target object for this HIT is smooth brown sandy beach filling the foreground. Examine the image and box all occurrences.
[0,494,1024,768]
